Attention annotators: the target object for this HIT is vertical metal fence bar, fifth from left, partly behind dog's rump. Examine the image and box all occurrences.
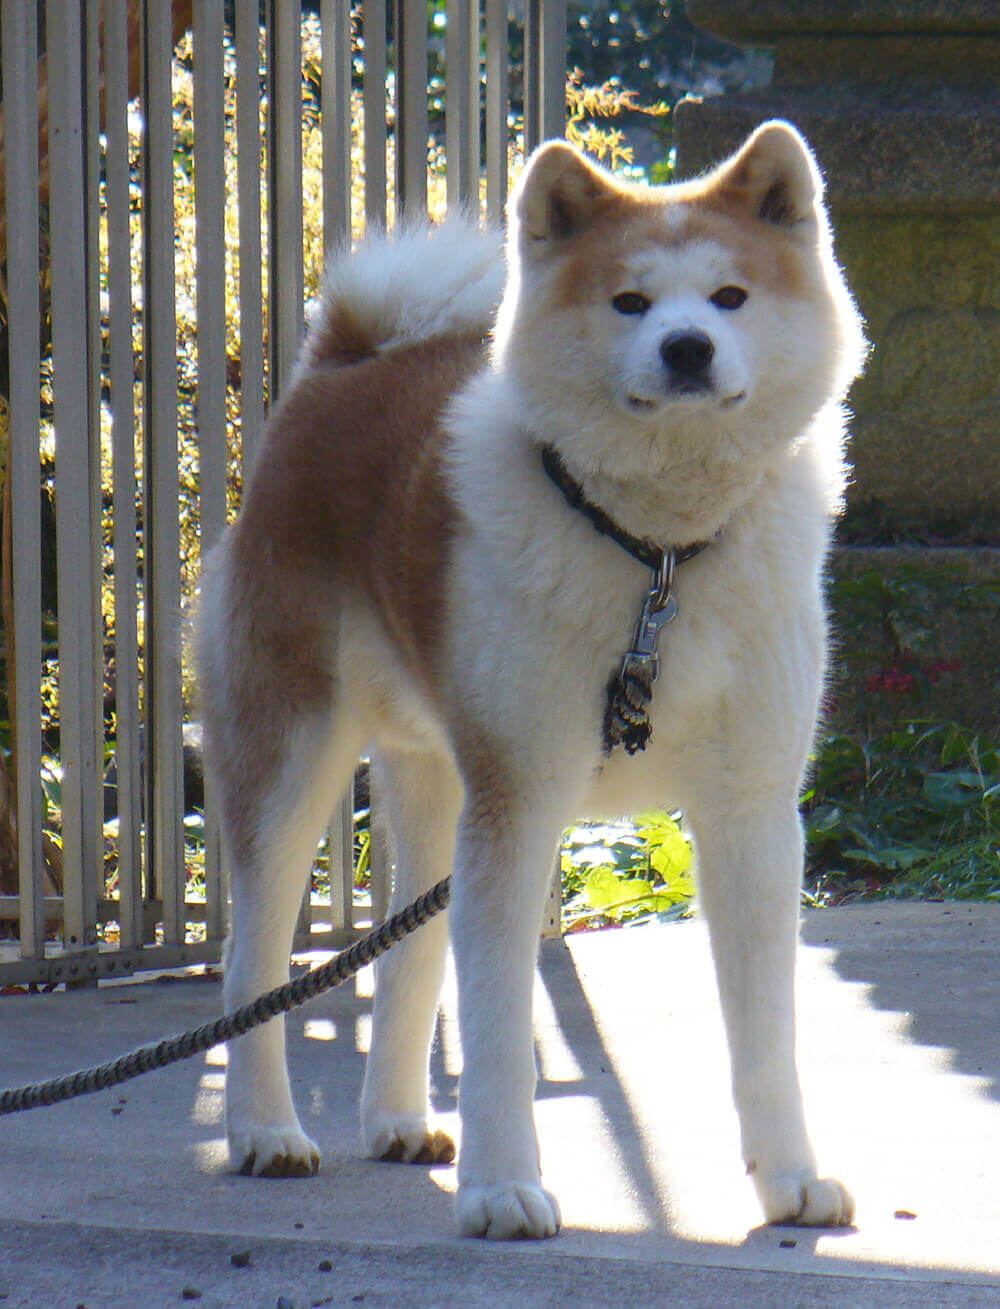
[194,0,226,940]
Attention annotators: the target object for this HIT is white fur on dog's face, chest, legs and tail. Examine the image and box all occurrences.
[207,128,861,1237]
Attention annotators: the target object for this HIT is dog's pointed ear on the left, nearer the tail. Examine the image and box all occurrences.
[510,141,616,254]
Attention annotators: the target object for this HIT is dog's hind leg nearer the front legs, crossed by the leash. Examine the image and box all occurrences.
[361,753,462,1164]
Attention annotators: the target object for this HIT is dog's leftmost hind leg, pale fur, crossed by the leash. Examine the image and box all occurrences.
[223,715,357,1177]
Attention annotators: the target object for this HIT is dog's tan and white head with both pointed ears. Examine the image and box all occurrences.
[496,122,861,500]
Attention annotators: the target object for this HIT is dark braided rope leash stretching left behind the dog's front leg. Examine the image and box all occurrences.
[0,877,452,1114]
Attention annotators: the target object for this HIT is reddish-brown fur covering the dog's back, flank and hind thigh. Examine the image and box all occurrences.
[209,332,483,853]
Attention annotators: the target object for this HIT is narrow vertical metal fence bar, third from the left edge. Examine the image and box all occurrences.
[105,0,143,949]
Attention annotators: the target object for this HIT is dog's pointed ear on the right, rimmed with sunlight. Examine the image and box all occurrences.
[708,119,823,228]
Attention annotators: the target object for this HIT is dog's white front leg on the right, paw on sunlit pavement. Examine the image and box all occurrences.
[688,795,853,1227]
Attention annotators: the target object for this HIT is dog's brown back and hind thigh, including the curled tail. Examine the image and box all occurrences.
[199,220,503,816]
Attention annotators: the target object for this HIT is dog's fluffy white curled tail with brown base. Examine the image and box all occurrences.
[300,217,504,368]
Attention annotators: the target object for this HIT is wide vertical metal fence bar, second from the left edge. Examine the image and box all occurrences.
[46,0,102,948]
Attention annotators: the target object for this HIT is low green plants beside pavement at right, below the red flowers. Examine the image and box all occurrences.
[802,723,1000,903]
